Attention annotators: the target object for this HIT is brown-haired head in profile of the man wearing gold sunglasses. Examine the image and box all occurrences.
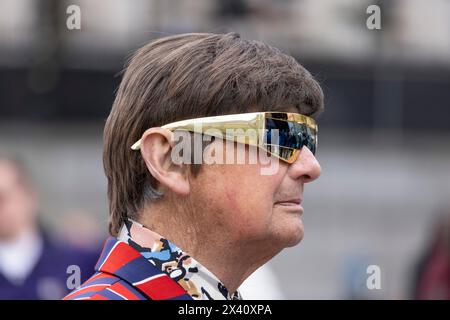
[104,34,323,250]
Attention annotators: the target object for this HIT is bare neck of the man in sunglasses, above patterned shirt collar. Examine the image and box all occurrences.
[139,202,276,293]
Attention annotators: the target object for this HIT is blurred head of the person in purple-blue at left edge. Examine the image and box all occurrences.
[0,154,37,239]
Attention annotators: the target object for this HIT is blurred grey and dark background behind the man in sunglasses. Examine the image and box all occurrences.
[0,0,450,299]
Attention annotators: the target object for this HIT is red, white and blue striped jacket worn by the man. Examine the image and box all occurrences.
[64,238,192,300]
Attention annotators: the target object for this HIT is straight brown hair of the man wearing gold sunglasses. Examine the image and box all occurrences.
[103,33,323,235]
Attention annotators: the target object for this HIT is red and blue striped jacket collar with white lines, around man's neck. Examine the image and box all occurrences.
[95,237,192,300]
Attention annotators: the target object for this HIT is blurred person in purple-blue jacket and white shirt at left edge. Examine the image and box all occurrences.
[0,154,97,300]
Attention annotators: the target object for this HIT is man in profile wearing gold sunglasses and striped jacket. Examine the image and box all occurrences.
[66,33,323,300]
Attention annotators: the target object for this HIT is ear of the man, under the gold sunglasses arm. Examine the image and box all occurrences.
[141,127,190,196]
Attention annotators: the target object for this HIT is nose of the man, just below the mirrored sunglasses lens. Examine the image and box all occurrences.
[289,146,322,183]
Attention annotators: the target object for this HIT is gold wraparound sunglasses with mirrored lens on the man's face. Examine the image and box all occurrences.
[131,112,318,163]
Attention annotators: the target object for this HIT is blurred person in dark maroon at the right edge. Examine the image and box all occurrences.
[414,209,450,300]
